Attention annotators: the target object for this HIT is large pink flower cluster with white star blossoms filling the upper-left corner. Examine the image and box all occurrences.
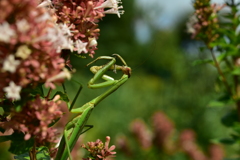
[0,0,70,100]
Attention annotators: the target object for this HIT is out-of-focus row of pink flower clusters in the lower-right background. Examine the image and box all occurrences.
[117,111,224,160]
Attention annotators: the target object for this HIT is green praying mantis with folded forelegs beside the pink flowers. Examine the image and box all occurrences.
[55,54,131,160]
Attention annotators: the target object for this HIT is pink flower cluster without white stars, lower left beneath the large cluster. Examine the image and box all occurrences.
[0,96,62,147]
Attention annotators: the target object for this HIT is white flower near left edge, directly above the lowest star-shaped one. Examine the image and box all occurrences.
[3,54,21,73]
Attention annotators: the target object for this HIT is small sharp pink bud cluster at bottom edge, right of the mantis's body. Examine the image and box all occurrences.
[82,136,116,160]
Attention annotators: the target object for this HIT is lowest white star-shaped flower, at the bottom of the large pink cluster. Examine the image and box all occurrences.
[3,81,22,100]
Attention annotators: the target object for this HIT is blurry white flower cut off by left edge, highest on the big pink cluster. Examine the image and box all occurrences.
[0,22,16,42]
